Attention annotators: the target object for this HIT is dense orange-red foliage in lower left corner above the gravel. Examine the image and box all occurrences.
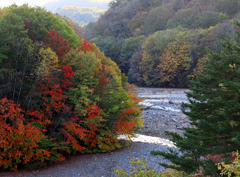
[0,98,51,170]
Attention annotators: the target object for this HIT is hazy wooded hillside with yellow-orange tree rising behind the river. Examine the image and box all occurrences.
[85,0,240,87]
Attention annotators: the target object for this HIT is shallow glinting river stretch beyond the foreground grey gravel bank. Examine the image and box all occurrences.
[120,88,188,147]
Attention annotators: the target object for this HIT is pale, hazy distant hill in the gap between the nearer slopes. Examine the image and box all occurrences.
[56,6,105,26]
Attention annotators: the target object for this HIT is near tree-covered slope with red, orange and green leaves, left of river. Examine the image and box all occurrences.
[0,5,142,170]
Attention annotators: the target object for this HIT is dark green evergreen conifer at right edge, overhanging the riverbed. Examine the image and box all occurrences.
[151,24,240,176]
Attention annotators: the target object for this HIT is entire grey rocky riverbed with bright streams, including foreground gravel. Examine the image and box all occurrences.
[0,88,189,177]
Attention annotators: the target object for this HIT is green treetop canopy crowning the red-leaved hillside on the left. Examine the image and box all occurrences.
[0,5,79,46]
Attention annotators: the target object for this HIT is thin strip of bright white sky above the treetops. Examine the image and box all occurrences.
[0,0,110,7]
